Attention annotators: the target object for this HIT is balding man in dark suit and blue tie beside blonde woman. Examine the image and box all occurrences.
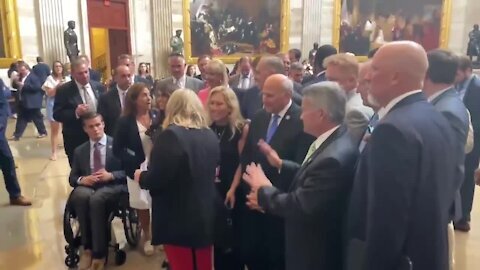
[237,74,314,270]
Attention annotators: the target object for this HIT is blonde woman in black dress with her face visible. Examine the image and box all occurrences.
[207,86,248,270]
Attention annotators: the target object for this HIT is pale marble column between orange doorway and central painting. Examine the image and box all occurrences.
[151,0,173,78]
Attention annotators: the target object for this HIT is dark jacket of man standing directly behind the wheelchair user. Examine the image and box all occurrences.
[97,86,122,136]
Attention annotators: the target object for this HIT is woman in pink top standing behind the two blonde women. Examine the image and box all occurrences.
[198,59,228,105]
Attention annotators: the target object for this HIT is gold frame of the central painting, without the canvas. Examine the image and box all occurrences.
[183,0,290,64]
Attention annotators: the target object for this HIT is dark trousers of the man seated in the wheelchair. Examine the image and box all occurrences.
[70,185,122,259]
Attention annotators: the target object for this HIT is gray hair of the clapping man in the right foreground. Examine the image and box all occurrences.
[303,82,347,124]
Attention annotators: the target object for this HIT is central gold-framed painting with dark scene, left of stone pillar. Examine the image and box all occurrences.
[183,0,290,64]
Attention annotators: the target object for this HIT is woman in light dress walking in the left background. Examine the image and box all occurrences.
[42,60,70,160]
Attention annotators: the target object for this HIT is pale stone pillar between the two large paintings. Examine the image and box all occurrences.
[302,0,324,55]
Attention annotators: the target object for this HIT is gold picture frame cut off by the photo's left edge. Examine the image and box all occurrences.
[0,0,22,68]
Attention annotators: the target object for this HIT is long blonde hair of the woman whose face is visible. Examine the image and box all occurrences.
[207,86,245,139]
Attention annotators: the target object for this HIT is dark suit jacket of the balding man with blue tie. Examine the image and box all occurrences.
[237,103,314,262]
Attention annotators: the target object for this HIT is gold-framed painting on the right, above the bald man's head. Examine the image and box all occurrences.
[333,0,452,57]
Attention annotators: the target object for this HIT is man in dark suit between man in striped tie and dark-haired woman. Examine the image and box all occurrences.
[98,65,132,136]
